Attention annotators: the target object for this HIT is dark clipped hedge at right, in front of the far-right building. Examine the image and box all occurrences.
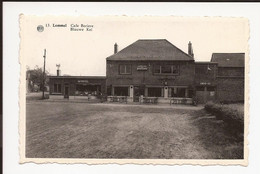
[204,102,244,135]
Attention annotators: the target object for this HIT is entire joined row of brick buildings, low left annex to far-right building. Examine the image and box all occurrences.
[47,39,245,104]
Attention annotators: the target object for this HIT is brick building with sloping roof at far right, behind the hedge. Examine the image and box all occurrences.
[211,53,245,103]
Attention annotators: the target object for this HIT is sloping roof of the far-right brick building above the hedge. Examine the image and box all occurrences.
[211,53,245,67]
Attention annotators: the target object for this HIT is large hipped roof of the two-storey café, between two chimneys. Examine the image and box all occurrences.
[107,39,194,61]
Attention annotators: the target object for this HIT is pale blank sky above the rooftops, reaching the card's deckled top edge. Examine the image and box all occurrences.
[20,16,249,76]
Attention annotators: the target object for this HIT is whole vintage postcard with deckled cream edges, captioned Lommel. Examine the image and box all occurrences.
[19,14,249,166]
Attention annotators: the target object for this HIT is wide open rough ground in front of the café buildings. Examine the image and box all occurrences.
[26,101,243,159]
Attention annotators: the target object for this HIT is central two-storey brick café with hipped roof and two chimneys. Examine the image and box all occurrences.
[106,39,195,103]
